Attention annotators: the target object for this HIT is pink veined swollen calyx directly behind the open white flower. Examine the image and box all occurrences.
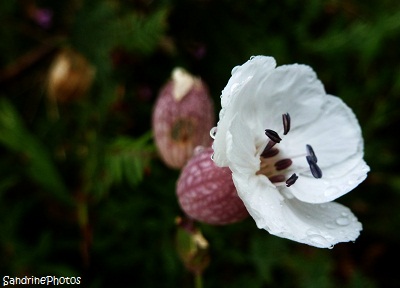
[176,148,249,225]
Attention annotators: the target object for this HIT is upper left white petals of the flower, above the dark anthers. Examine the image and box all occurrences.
[213,56,325,166]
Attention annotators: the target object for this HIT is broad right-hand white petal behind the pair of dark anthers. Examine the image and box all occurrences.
[280,96,369,203]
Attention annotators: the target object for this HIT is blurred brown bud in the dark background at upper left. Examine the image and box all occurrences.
[47,49,95,103]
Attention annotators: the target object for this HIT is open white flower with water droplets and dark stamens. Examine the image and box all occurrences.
[211,56,369,248]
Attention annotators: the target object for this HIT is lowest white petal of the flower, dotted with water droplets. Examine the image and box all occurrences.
[233,173,362,248]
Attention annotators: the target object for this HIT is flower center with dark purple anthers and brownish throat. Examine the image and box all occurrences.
[256,113,322,187]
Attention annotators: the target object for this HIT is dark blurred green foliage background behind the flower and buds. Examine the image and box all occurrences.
[0,0,400,287]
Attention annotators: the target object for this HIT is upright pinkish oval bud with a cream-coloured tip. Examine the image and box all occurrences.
[153,68,214,169]
